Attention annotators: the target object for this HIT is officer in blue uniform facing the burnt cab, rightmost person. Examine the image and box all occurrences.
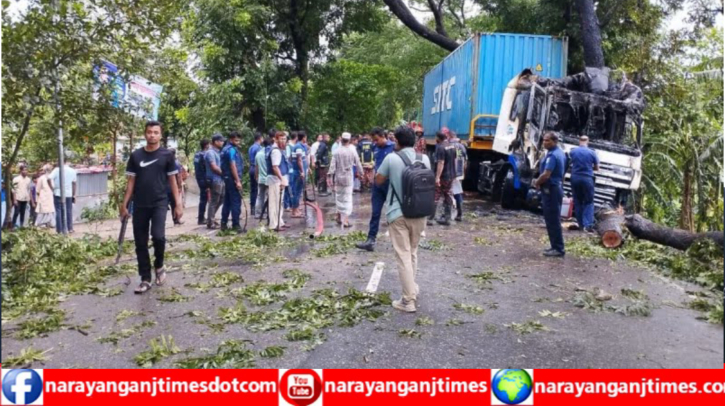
[569,135,599,233]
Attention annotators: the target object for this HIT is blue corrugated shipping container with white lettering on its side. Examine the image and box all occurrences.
[423,33,568,143]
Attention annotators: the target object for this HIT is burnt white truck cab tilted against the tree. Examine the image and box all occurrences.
[478,69,643,208]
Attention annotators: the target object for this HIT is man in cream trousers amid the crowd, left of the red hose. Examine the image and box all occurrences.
[266,131,289,232]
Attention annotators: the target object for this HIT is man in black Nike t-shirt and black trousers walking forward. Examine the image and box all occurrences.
[121,121,183,294]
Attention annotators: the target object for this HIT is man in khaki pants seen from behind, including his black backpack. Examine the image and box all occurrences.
[375,126,435,313]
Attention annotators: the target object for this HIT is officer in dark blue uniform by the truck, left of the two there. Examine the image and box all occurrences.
[534,131,566,257]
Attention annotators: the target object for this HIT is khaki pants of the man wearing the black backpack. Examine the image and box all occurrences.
[388,217,426,301]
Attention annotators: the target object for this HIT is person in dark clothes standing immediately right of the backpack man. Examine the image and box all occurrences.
[428,128,456,226]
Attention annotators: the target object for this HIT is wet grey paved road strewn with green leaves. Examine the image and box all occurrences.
[2,190,723,368]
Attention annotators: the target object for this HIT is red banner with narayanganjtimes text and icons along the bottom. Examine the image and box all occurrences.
[2,369,725,406]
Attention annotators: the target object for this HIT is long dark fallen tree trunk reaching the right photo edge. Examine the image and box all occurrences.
[624,214,725,251]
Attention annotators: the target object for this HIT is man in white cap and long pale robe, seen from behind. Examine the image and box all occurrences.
[327,132,363,227]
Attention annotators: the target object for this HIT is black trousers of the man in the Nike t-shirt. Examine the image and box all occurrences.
[133,205,167,282]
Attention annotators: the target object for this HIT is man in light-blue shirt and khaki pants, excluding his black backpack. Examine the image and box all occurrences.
[375,126,431,312]
